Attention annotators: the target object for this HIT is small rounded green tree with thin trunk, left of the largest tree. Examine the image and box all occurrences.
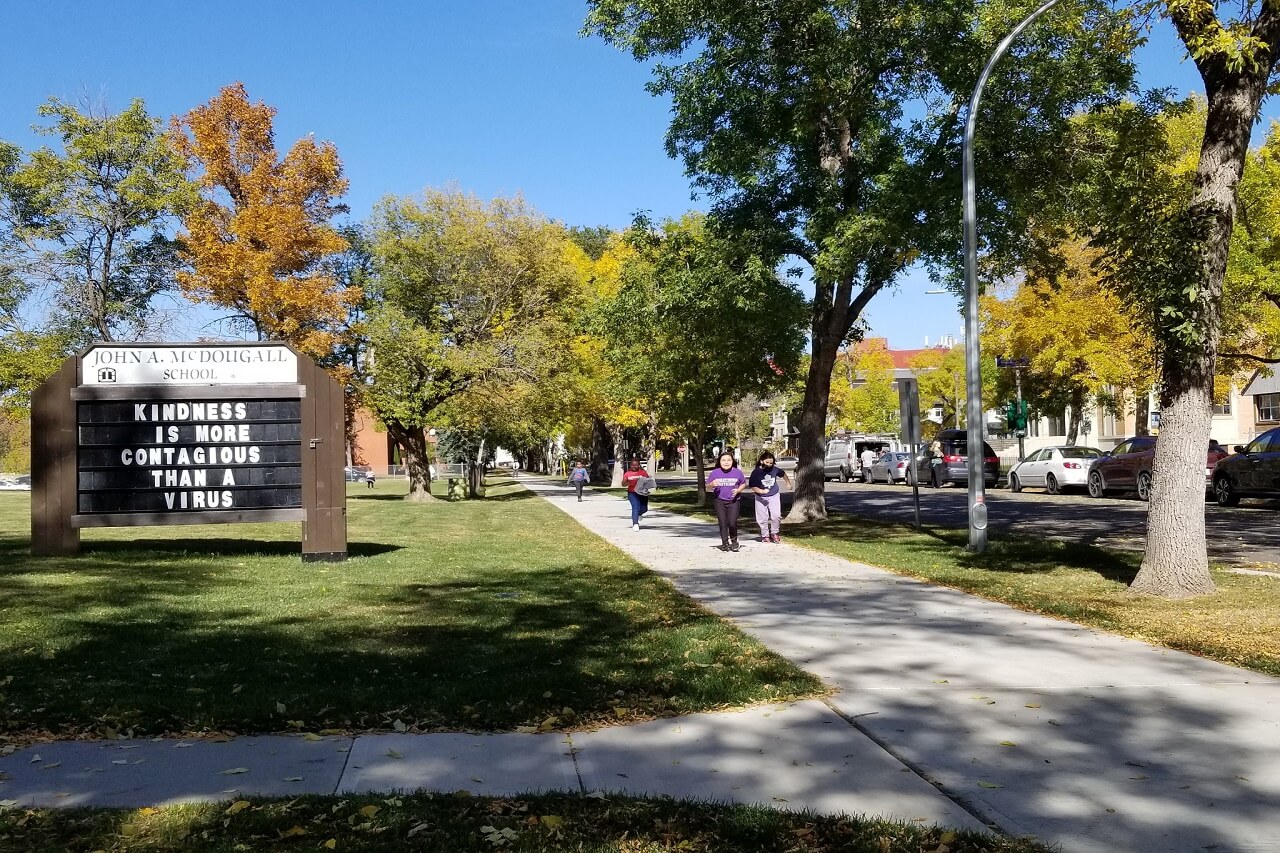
[602,214,804,501]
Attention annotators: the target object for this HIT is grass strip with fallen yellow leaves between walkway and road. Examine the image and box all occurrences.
[654,488,1280,675]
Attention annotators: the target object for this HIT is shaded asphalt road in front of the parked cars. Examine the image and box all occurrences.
[663,476,1280,569]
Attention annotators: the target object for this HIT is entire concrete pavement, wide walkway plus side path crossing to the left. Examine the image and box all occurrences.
[0,478,1280,853]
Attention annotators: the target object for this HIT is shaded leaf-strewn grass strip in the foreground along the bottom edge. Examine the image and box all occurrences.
[0,794,1048,853]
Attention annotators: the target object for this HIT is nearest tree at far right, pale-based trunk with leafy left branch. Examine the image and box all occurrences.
[1064,6,1280,598]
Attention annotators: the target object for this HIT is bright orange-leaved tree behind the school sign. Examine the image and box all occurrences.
[170,83,360,357]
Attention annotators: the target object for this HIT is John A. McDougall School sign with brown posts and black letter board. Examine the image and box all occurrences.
[32,343,347,560]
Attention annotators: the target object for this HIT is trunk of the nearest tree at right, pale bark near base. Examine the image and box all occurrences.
[1132,63,1259,598]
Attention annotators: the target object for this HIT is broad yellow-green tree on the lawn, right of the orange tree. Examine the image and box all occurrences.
[364,190,582,500]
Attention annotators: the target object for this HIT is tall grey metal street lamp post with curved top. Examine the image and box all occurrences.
[961,0,1057,553]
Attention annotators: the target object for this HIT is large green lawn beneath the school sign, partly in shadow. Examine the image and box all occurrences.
[0,482,823,737]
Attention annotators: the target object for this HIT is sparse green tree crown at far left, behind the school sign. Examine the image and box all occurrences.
[0,99,193,346]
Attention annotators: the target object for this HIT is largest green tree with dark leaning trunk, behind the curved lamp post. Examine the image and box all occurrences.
[586,0,1134,520]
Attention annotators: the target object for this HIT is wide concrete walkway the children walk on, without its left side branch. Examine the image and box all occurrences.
[525,479,1280,853]
